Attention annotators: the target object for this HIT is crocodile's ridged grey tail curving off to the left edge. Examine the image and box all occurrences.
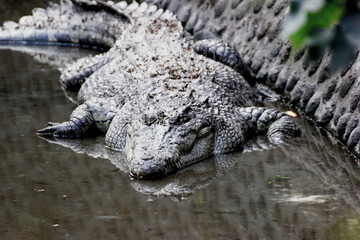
[0,0,131,48]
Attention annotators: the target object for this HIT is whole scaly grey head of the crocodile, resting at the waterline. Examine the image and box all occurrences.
[106,108,215,178]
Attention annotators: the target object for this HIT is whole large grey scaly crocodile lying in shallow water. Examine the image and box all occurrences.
[0,0,300,179]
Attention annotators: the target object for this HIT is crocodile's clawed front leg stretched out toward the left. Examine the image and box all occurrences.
[37,104,94,138]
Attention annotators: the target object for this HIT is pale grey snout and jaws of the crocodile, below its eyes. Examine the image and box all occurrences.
[124,122,215,179]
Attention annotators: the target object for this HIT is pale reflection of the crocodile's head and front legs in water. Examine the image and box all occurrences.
[38,136,278,201]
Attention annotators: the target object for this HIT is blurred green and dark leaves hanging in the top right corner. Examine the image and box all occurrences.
[282,0,360,72]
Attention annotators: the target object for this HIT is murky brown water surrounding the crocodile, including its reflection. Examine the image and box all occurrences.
[0,1,360,239]
